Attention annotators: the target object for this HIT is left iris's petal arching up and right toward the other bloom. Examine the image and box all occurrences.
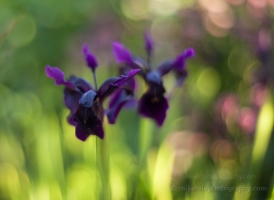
[97,69,140,101]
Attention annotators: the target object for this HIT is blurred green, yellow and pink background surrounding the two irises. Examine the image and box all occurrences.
[0,0,274,200]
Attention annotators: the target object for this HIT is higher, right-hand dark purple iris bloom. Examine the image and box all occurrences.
[113,33,195,126]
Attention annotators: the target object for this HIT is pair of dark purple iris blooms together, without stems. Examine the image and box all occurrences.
[46,34,194,141]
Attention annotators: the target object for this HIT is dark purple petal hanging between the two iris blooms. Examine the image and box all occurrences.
[106,89,133,124]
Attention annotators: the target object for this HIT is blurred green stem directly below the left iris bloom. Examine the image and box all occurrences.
[96,118,111,200]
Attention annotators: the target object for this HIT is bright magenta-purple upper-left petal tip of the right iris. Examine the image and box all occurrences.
[112,42,133,64]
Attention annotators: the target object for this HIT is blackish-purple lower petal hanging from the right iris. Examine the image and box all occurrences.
[138,93,169,126]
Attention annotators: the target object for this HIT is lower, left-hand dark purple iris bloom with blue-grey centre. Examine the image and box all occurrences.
[46,46,140,141]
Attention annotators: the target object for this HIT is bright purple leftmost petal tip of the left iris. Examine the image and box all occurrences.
[45,65,74,88]
